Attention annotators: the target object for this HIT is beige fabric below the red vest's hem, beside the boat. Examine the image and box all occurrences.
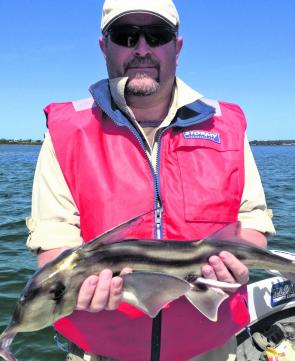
[190,337,237,361]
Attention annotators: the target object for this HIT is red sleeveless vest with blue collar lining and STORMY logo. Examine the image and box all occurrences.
[45,80,249,361]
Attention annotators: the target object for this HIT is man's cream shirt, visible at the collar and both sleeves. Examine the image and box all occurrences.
[27,78,275,251]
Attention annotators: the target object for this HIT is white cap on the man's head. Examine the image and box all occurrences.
[101,0,179,32]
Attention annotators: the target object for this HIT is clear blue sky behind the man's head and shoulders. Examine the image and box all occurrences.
[0,0,295,140]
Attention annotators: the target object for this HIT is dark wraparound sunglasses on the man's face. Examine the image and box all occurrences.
[104,25,177,48]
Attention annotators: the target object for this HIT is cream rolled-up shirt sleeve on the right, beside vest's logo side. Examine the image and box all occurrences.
[238,137,275,235]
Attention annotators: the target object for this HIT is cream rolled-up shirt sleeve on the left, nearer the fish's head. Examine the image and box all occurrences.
[26,133,82,252]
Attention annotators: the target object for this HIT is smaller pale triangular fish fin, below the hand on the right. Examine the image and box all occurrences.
[185,287,229,322]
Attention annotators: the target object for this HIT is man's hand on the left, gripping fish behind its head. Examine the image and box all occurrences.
[76,268,131,312]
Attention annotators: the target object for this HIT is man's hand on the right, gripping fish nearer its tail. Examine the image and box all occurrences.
[201,251,249,284]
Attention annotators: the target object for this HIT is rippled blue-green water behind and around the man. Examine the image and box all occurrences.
[0,145,295,361]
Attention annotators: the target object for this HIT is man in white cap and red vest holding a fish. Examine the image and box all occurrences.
[28,0,274,361]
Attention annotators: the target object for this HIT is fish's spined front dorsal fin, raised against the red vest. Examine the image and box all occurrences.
[83,209,156,250]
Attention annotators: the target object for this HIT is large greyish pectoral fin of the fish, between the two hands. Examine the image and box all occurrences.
[123,272,191,318]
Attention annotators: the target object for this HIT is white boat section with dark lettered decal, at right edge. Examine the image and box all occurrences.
[236,250,295,361]
